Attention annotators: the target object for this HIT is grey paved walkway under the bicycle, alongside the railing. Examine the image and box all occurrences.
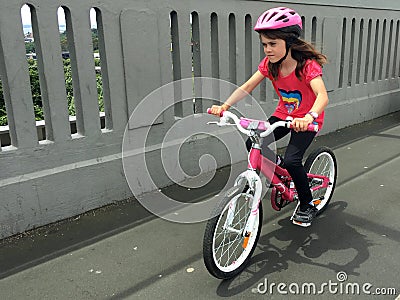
[0,113,400,299]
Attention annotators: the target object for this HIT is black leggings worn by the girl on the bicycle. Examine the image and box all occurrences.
[246,116,316,207]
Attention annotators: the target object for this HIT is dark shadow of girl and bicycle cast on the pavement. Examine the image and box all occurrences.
[217,201,376,297]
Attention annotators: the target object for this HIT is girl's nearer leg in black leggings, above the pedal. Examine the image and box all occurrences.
[284,131,316,211]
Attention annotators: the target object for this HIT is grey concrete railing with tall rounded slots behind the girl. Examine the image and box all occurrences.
[0,0,400,238]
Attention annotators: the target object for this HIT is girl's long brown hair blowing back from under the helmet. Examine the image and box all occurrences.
[259,30,327,80]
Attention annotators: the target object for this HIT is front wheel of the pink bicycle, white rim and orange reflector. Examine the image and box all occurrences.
[203,185,262,279]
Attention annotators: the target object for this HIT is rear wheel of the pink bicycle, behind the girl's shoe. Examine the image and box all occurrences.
[304,147,337,215]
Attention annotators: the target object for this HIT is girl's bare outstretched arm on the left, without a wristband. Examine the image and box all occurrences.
[211,71,265,116]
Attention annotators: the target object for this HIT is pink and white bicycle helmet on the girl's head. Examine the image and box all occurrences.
[254,7,303,37]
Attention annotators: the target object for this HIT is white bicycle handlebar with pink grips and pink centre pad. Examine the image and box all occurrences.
[207,108,318,137]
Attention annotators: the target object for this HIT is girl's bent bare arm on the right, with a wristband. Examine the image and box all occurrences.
[292,76,329,131]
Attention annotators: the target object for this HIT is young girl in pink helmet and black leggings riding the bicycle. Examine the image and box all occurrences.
[211,7,328,224]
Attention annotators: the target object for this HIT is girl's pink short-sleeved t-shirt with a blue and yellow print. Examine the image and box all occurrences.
[258,57,324,128]
